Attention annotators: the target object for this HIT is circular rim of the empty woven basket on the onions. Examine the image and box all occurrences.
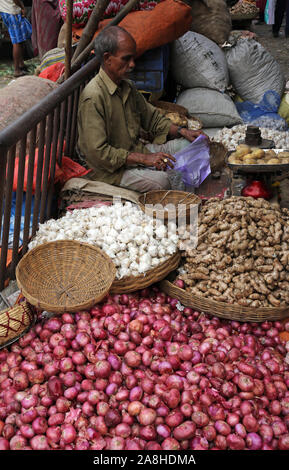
[15,240,116,313]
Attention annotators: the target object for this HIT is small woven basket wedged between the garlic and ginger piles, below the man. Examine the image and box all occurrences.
[139,190,201,222]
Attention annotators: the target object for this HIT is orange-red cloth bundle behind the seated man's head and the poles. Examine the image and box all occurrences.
[72,0,192,57]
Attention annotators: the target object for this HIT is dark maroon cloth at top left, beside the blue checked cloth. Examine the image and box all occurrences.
[31,0,63,58]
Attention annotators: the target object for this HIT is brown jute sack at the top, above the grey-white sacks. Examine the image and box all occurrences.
[186,0,232,45]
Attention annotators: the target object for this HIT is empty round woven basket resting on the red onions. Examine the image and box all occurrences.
[16,240,116,313]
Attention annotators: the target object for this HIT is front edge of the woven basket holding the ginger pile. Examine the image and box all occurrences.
[160,280,289,323]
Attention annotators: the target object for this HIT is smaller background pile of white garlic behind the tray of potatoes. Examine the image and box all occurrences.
[213,125,289,150]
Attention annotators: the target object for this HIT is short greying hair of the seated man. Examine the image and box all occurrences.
[94,26,135,64]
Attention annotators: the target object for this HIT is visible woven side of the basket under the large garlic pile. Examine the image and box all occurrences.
[110,252,181,294]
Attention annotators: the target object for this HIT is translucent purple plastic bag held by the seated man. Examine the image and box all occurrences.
[174,135,211,188]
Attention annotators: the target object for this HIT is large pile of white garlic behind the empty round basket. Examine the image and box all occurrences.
[29,202,179,279]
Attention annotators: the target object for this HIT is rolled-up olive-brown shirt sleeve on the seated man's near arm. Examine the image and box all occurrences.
[78,99,129,173]
